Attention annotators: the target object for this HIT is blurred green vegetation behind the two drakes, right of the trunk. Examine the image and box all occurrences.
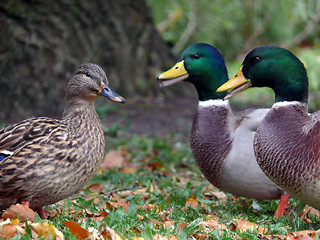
[147,0,320,110]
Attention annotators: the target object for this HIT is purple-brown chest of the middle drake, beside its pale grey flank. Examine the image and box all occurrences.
[190,106,232,187]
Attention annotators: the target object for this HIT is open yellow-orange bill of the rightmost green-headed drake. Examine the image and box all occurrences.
[217,66,252,99]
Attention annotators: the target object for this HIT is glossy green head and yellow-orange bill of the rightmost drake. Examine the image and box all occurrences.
[217,46,308,103]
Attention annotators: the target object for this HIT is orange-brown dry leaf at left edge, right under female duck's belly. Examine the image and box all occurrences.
[1,204,35,221]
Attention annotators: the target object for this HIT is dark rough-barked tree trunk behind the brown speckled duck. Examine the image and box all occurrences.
[0,0,173,119]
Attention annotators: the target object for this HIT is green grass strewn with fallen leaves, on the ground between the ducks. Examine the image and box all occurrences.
[3,130,319,239]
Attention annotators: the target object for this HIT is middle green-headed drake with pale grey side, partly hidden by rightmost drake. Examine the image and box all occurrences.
[157,43,284,199]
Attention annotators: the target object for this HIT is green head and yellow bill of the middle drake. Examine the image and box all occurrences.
[157,43,228,101]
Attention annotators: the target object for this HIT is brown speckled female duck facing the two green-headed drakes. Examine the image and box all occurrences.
[0,63,125,217]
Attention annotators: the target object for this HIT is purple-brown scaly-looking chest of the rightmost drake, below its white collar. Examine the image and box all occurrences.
[254,105,320,193]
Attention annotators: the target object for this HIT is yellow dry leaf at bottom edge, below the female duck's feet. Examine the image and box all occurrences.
[30,222,64,240]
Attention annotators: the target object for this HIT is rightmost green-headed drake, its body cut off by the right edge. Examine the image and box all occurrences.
[218,46,320,209]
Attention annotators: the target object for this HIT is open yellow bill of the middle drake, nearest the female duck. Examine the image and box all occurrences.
[157,60,189,87]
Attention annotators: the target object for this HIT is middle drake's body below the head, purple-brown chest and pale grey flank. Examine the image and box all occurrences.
[191,100,283,199]
